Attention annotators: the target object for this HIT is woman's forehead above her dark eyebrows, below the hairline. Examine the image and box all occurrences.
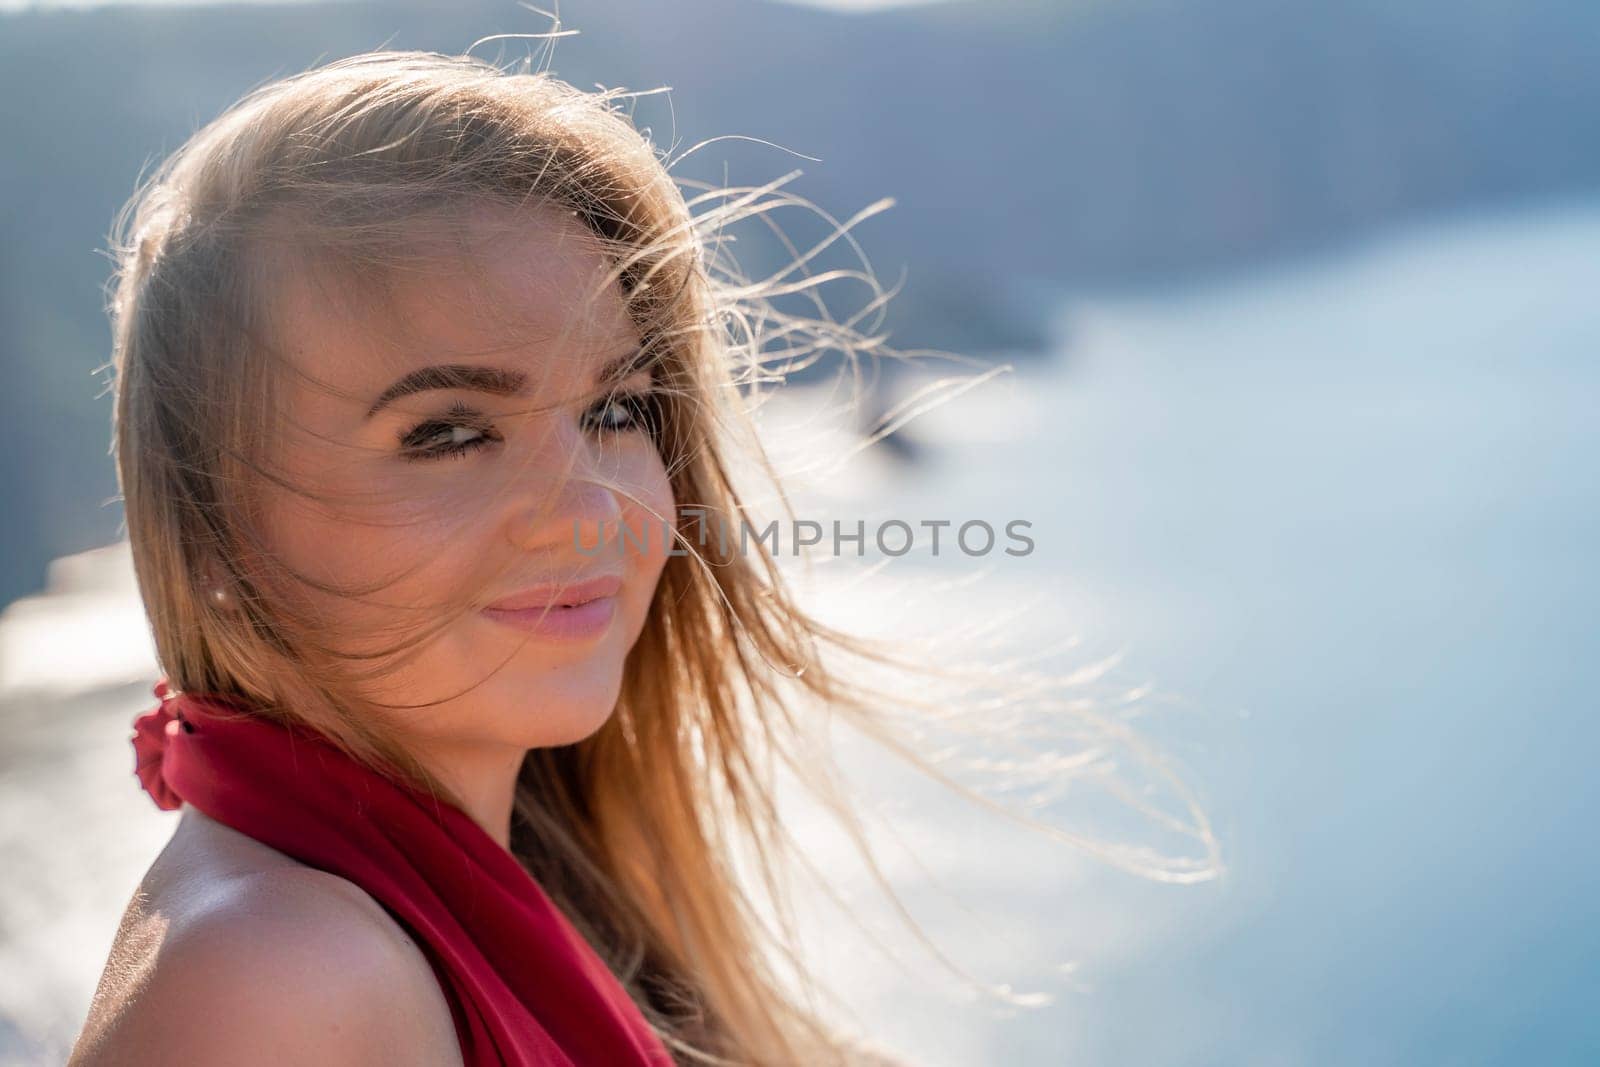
[272,210,640,397]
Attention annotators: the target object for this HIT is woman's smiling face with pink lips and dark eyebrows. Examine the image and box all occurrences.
[262,204,674,764]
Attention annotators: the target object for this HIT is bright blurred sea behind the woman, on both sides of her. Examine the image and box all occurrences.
[0,202,1600,1065]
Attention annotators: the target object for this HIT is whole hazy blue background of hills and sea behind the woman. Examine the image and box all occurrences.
[0,0,1600,1065]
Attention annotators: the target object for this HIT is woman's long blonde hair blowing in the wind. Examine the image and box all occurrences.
[110,45,1214,1064]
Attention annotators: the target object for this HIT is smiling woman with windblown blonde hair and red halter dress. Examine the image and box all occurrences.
[72,43,1209,1067]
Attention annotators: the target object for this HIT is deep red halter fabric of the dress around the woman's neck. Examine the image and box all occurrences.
[133,680,672,1067]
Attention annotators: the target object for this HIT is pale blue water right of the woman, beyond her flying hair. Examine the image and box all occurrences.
[793,195,1600,1065]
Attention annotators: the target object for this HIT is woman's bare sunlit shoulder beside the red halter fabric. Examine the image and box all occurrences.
[70,809,461,1067]
